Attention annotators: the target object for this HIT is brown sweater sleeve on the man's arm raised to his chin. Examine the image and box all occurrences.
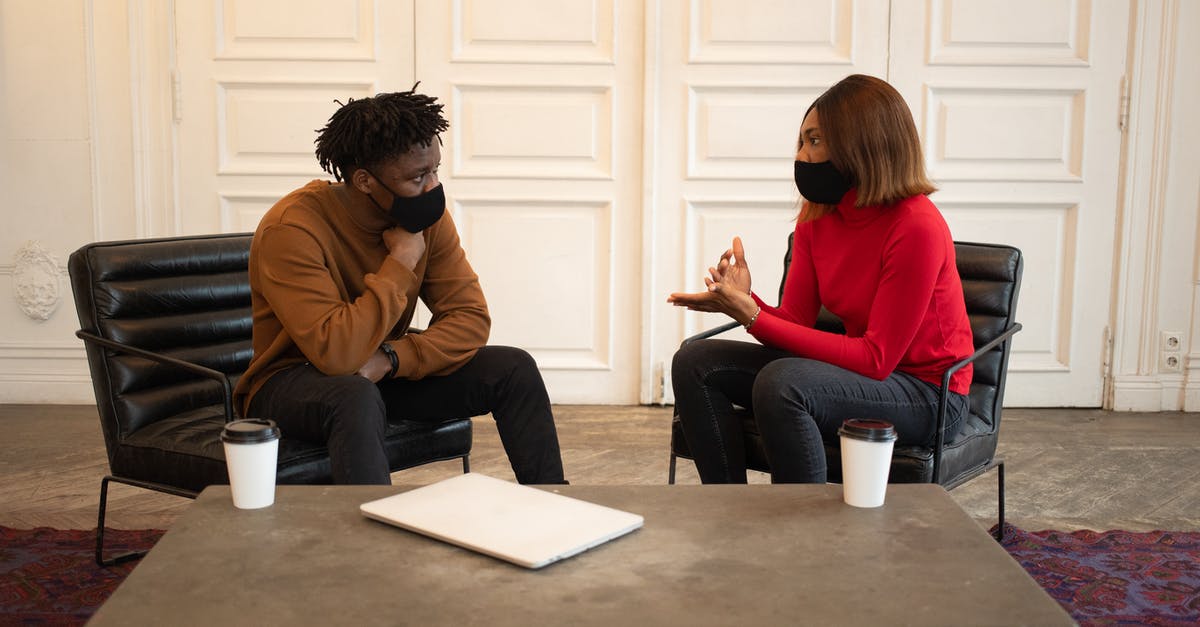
[256,223,416,375]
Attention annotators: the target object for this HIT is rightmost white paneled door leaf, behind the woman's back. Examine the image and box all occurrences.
[888,0,1129,407]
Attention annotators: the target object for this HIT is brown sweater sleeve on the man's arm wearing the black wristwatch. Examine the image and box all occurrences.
[391,213,492,380]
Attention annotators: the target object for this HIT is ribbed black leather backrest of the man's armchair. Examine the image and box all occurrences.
[68,233,252,456]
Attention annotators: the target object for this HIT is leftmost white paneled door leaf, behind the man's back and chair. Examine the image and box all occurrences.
[174,0,413,233]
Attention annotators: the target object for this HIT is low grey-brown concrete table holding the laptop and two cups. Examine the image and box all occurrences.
[92,485,1073,627]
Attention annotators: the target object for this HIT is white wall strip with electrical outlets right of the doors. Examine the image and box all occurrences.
[1098,0,1200,411]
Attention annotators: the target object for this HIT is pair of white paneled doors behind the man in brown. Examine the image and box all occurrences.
[175,0,642,404]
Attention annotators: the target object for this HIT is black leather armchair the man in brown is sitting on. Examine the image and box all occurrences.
[68,233,472,566]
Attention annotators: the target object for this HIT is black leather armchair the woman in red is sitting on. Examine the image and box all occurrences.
[667,237,1022,533]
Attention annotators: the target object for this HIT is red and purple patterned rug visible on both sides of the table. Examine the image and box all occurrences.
[0,525,1200,626]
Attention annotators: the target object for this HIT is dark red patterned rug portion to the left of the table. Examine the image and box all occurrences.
[0,527,163,625]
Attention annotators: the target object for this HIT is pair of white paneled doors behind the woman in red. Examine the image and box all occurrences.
[644,0,1129,407]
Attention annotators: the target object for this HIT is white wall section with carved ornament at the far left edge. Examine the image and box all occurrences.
[0,0,95,402]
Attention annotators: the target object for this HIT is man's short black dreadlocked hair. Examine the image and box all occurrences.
[316,83,450,181]
